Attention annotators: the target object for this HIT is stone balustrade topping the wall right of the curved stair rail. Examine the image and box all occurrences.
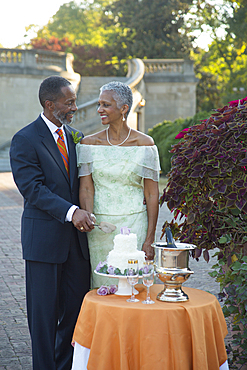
[143,59,194,75]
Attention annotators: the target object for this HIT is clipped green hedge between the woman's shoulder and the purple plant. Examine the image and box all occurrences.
[148,112,210,174]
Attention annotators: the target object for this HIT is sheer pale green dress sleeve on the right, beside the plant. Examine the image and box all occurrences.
[133,145,160,182]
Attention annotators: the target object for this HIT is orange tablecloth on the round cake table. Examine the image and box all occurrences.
[73,284,227,370]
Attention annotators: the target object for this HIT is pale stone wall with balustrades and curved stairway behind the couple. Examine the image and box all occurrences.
[0,48,197,146]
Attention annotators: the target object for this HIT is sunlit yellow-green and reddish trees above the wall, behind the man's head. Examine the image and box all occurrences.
[28,0,122,76]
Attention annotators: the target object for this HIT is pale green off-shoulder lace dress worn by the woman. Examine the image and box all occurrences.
[76,144,160,288]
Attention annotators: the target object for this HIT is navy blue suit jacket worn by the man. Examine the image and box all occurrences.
[10,116,89,263]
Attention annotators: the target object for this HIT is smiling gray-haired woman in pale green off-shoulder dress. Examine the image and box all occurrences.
[77,82,160,287]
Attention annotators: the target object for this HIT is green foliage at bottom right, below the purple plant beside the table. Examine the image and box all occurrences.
[210,253,247,369]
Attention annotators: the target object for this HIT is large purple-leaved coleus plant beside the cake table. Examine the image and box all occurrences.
[160,97,247,264]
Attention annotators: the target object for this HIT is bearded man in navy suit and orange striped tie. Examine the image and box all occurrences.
[10,76,93,370]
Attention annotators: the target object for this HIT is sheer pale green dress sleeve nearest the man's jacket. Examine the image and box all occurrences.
[76,144,93,177]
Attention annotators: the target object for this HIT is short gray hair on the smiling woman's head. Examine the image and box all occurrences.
[100,81,133,116]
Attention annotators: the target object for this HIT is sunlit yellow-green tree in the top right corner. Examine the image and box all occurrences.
[190,0,247,110]
